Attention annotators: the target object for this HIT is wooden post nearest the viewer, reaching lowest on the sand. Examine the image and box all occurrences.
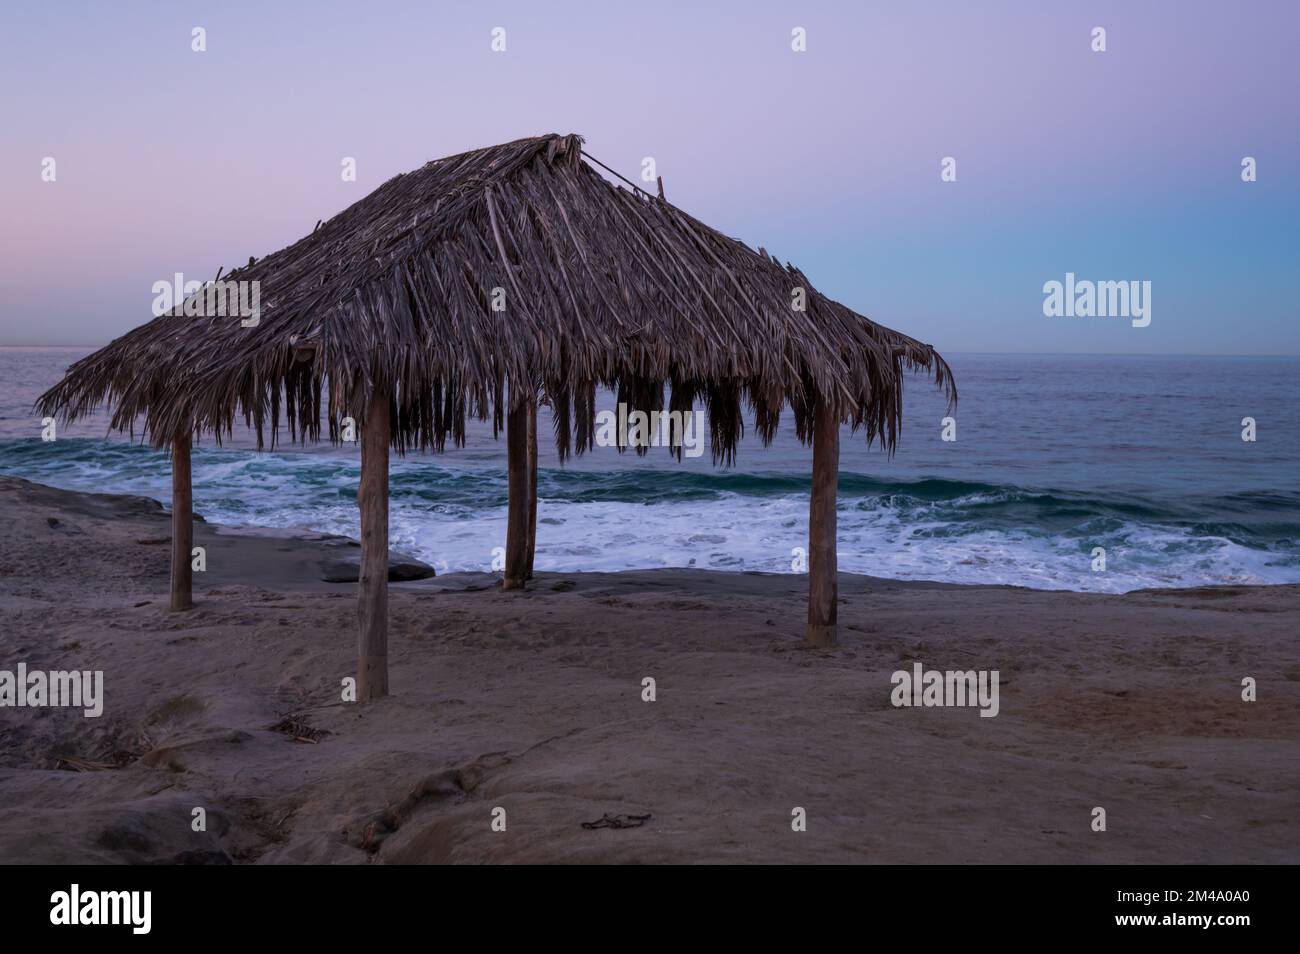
[356,387,391,702]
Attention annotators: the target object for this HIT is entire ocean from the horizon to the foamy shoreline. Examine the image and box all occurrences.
[0,348,1300,593]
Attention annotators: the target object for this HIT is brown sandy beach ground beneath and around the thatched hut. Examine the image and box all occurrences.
[0,477,1300,863]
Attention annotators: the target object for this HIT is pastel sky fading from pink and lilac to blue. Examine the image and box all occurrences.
[0,0,1300,355]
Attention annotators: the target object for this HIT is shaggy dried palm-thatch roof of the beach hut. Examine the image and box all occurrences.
[36,135,957,461]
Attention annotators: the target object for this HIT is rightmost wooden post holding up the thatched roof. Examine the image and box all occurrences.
[803,404,840,646]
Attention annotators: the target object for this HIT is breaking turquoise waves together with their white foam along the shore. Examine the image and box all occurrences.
[0,439,1300,589]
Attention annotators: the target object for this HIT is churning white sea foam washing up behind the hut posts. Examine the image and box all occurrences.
[2,442,1300,593]
